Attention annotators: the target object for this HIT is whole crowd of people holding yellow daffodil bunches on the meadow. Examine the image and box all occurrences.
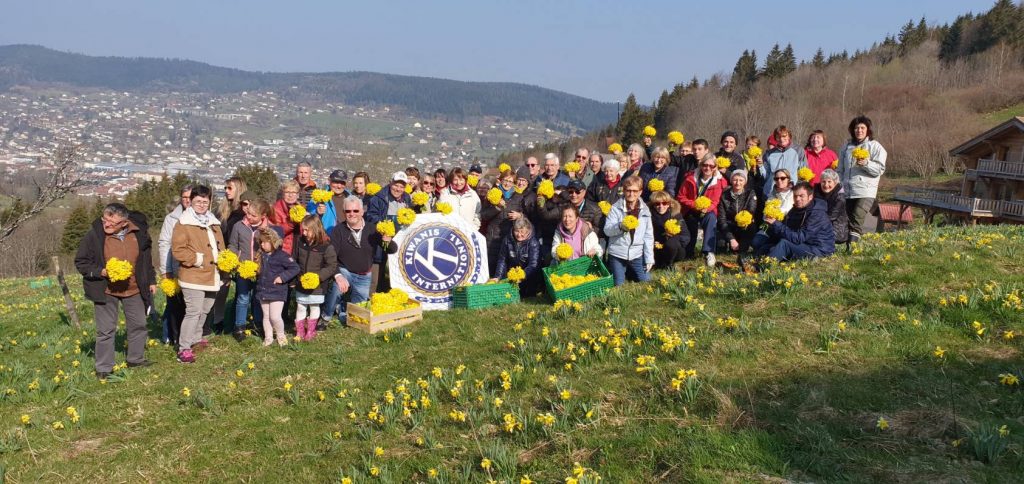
[75,116,887,378]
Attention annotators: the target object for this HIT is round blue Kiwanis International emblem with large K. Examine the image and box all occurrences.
[398,223,479,297]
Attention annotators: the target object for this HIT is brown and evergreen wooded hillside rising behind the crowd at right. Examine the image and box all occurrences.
[502,0,1024,177]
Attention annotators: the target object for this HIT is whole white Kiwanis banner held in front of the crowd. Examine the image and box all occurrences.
[388,214,490,310]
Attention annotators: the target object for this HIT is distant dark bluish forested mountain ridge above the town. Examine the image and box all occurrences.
[0,44,615,130]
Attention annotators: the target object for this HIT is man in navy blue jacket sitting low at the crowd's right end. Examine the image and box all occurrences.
[754,181,836,261]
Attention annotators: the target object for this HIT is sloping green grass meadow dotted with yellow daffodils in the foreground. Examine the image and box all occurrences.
[0,227,1024,482]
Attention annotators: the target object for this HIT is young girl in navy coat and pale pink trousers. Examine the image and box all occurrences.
[256,228,299,346]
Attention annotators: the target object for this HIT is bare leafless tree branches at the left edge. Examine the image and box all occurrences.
[0,144,82,246]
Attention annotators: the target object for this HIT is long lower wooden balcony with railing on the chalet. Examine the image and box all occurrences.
[893,186,1024,222]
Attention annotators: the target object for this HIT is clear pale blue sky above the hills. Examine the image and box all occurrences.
[0,0,993,102]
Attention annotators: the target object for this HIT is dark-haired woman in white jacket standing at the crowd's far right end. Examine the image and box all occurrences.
[838,116,889,241]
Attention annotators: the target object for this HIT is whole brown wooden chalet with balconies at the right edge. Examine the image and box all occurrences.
[893,116,1024,224]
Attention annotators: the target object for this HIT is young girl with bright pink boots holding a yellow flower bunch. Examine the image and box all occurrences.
[295,215,338,341]
